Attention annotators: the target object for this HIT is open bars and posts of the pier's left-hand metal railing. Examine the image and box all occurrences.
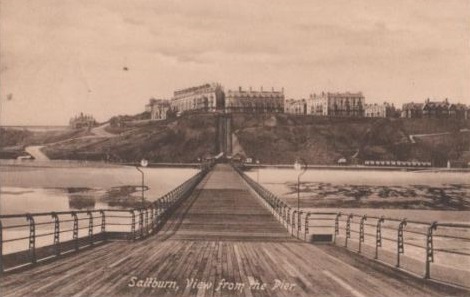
[0,164,213,274]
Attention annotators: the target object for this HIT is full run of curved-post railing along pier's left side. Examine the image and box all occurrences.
[0,166,210,273]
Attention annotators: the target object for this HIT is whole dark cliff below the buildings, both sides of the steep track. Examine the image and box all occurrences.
[5,113,470,166]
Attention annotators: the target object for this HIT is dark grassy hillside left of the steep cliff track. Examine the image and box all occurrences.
[44,114,216,162]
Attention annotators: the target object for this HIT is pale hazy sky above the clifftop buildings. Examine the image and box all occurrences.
[0,0,470,125]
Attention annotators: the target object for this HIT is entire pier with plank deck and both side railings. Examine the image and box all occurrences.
[0,164,469,297]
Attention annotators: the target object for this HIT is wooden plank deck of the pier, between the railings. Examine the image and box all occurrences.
[0,165,468,297]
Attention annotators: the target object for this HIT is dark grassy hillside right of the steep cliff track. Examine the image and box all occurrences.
[233,114,470,164]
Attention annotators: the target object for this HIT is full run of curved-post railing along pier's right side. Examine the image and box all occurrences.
[235,167,470,287]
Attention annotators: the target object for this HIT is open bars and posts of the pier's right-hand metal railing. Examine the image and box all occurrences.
[234,166,470,285]
